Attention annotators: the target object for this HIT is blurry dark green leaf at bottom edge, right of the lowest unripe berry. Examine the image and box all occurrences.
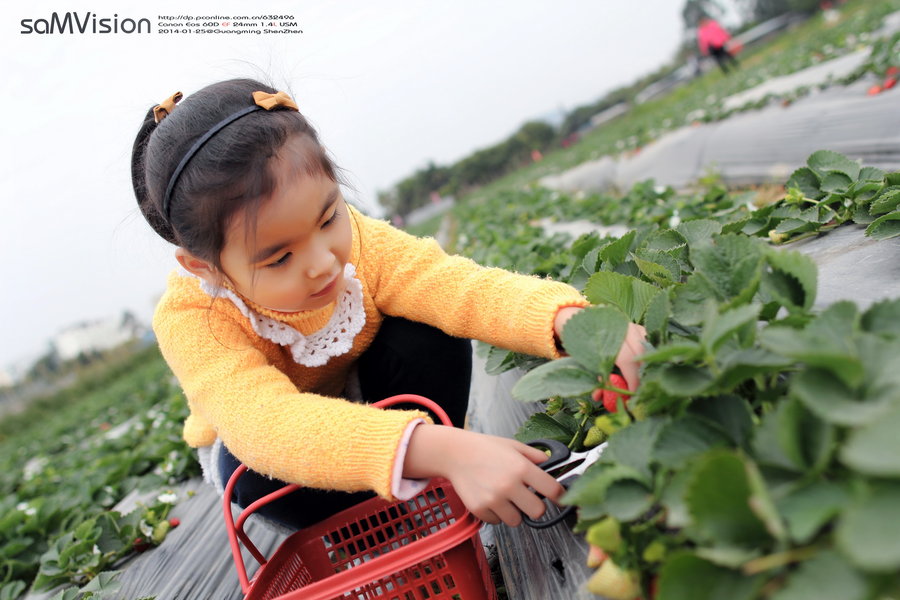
[656,552,765,600]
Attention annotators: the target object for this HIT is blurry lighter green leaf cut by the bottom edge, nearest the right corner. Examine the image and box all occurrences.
[772,550,870,600]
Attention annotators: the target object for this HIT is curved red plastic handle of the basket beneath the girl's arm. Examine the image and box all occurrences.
[222,394,452,594]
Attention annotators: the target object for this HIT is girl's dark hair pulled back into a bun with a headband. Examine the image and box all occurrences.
[131,79,340,269]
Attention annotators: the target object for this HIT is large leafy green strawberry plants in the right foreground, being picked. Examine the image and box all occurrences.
[464,151,900,600]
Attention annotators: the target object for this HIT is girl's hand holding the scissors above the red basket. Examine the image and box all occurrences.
[403,424,565,527]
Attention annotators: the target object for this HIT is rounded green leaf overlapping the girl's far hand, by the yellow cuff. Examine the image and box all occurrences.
[562,306,628,376]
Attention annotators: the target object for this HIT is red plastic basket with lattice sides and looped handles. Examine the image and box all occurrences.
[223,394,497,600]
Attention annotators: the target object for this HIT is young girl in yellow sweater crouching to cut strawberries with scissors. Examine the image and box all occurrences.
[132,79,643,527]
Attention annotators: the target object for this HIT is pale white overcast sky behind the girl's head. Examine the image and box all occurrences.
[0,0,696,369]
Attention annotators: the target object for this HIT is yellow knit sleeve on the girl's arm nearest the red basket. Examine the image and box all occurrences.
[153,278,427,498]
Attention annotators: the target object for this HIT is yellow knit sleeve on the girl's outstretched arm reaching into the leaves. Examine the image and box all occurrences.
[359,212,590,358]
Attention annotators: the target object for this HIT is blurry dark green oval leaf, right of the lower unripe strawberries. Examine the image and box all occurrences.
[685,451,771,547]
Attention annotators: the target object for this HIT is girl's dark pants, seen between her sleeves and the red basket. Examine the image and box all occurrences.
[218,317,472,529]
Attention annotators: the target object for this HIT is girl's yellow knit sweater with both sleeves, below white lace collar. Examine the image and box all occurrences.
[153,210,588,498]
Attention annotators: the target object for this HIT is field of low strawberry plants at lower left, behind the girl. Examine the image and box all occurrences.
[0,348,199,600]
